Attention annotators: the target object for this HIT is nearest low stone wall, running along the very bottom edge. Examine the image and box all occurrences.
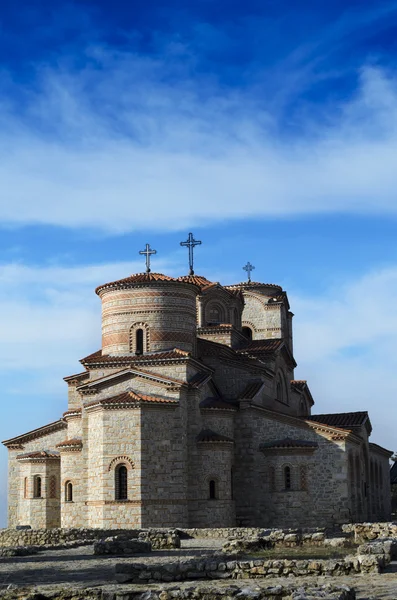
[1,584,356,600]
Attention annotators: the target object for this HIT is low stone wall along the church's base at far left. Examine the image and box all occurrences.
[0,528,180,550]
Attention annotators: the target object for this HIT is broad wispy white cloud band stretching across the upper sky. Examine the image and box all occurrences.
[0,48,397,231]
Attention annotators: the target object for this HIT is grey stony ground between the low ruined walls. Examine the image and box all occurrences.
[0,539,397,600]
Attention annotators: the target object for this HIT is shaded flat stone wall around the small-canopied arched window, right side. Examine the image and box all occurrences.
[235,407,349,527]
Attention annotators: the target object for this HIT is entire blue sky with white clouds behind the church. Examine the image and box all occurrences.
[0,0,397,527]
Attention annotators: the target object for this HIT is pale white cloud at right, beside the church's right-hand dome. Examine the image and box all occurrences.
[291,267,397,450]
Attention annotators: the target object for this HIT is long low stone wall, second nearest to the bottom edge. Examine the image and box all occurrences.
[115,554,385,583]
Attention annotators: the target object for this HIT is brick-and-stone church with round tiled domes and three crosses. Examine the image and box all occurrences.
[3,234,392,529]
